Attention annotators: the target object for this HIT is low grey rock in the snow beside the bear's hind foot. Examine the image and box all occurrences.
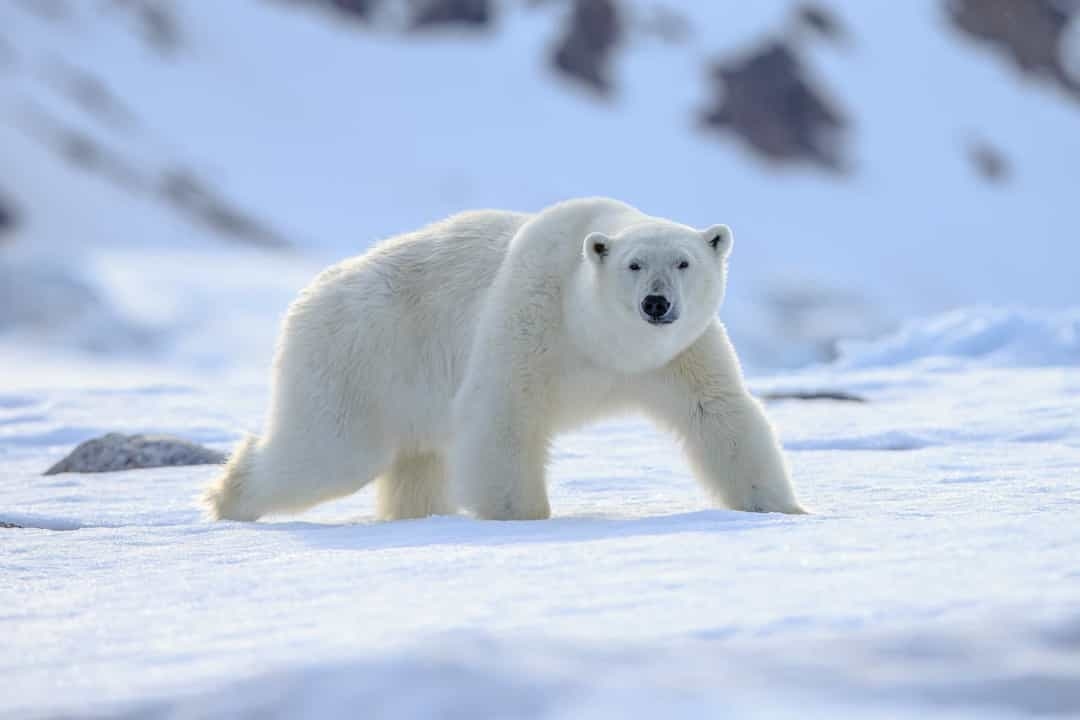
[44,433,225,475]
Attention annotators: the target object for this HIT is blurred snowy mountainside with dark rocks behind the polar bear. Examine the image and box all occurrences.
[0,0,1080,373]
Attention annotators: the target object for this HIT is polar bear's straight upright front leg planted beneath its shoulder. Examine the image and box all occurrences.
[450,373,551,520]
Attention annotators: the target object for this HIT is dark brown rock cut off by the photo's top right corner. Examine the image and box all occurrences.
[945,0,1080,100]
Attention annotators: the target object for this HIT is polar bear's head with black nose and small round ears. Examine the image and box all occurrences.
[583,220,734,369]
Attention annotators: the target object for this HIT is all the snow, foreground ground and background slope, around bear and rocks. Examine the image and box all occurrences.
[0,0,1080,719]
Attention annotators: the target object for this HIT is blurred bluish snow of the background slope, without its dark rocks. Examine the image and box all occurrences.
[0,0,1080,367]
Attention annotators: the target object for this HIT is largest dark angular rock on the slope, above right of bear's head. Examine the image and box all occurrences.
[702,41,849,172]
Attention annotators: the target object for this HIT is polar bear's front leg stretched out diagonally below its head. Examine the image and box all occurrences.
[643,322,806,513]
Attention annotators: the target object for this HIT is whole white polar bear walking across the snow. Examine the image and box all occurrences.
[203,199,805,520]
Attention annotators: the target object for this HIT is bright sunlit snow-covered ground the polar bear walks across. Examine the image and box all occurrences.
[0,316,1080,718]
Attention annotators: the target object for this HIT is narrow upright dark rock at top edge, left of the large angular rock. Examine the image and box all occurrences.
[552,0,622,93]
